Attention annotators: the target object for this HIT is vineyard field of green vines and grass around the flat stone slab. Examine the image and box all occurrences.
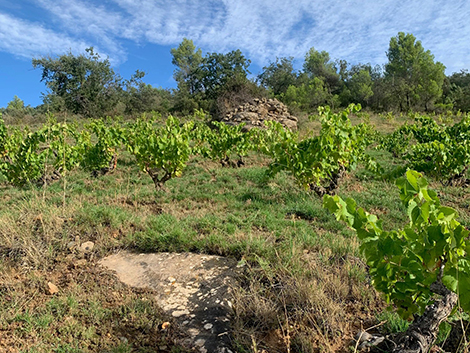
[0,105,470,352]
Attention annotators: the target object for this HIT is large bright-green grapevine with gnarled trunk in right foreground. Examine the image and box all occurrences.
[323,170,470,352]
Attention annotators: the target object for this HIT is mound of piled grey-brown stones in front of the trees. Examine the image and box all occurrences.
[222,98,297,130]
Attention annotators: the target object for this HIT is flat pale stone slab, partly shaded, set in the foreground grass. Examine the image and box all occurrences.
[100,251,238,353]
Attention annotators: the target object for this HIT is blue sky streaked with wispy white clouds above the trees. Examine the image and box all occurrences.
[0,0,470,106]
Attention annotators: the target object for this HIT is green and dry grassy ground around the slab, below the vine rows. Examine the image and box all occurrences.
[0,118,470,352]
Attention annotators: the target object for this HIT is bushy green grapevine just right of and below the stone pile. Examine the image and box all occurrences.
[265,105,380,196]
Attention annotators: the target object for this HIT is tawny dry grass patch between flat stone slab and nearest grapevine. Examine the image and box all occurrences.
[231,246,384,353]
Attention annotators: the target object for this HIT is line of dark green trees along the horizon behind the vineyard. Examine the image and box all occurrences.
[1,32,470,117]
